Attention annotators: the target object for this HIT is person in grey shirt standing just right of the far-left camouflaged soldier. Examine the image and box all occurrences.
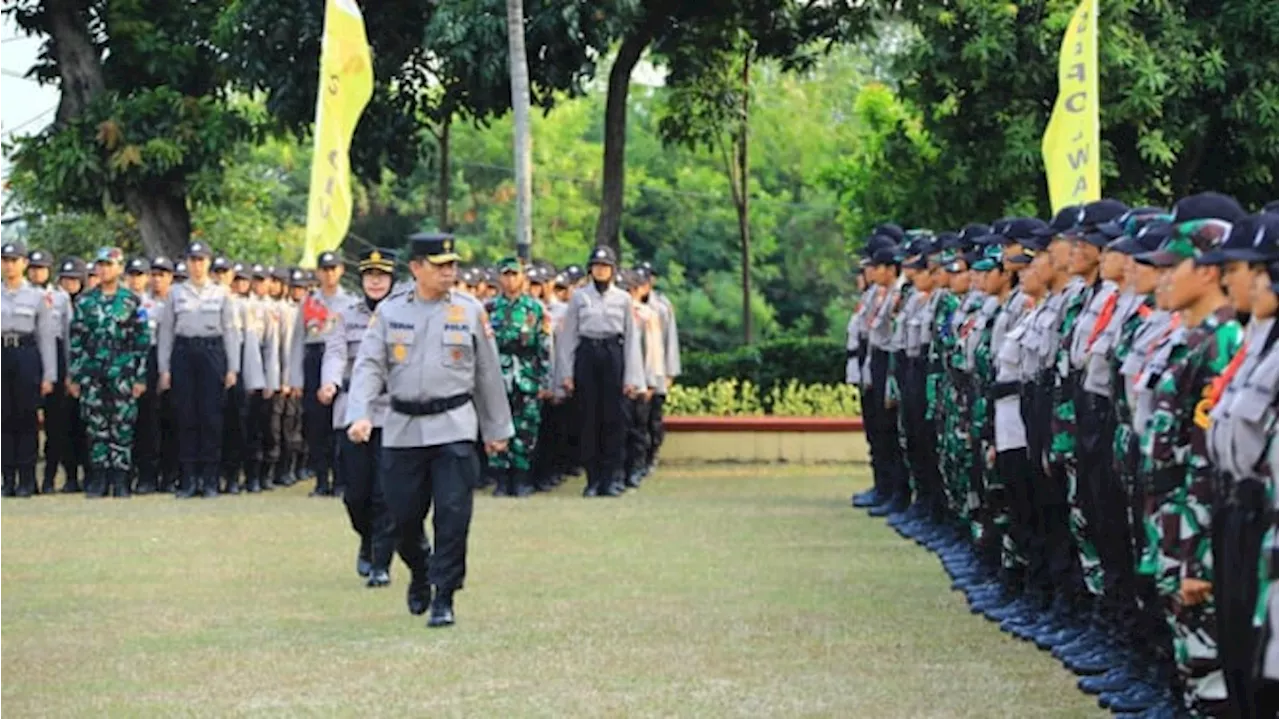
[157,242,241,499]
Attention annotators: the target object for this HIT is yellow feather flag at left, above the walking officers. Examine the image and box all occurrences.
[300,0,374,267]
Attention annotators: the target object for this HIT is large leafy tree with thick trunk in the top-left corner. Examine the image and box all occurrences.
[0,0,252,253]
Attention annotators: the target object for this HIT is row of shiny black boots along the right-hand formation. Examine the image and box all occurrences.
[854,489,1192,719]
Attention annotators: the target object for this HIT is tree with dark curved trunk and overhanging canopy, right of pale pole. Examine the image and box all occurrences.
[595,0,870,248]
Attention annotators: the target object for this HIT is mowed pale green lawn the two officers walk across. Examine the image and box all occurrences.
[0,467,1105,719]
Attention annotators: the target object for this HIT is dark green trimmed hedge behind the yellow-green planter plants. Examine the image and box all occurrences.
[678,338,845,394]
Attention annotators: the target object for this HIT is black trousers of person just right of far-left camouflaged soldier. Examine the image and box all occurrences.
[169,336,227,477]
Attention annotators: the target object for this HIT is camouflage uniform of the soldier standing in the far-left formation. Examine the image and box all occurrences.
[68,287,151,478]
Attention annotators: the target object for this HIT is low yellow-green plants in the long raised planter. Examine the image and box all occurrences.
[664,379,861,417]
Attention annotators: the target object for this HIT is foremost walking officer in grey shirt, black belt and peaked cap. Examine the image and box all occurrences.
[347,234,515,627]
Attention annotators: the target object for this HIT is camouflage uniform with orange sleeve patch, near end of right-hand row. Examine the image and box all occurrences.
[1139,307,1243,695]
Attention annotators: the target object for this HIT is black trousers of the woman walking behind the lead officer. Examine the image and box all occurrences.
[338,429,394,569]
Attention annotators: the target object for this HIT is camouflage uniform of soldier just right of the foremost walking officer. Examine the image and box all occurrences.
[489,294,552,472]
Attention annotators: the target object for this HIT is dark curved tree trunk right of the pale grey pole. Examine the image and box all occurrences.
[595,26,653,256]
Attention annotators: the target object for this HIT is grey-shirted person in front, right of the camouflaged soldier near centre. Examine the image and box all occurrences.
[556,247,645,496]
